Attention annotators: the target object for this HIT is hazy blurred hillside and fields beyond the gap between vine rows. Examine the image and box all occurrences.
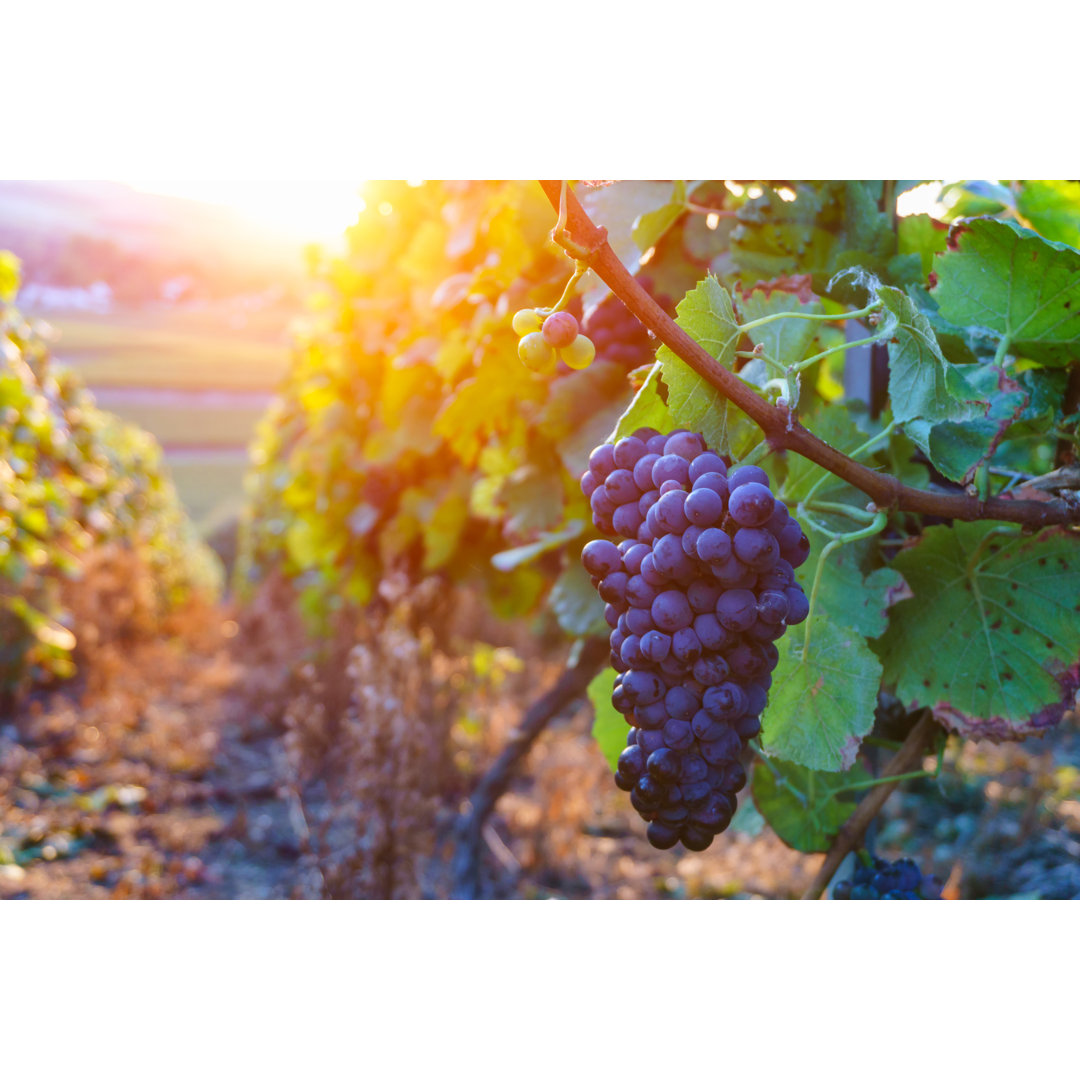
[0,180,330,555]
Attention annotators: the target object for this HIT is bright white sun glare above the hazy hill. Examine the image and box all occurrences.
[126,180,367,242]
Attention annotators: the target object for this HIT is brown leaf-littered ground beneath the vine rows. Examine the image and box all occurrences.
[0,608,1080,899]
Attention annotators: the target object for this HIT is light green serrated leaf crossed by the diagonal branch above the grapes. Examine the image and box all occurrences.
[657,274,750,454]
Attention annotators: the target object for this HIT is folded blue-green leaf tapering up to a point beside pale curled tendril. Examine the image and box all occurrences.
[877,285,978,423]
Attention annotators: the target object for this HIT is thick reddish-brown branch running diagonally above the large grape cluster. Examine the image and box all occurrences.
[539,180,1080,529]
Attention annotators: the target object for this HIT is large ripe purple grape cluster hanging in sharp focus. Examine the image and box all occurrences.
[581,428,810,851]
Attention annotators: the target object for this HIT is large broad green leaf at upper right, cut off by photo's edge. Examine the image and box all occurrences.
[932,218,1080,365]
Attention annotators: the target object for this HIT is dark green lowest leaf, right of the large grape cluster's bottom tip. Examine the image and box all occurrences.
[750,758,870,851]
